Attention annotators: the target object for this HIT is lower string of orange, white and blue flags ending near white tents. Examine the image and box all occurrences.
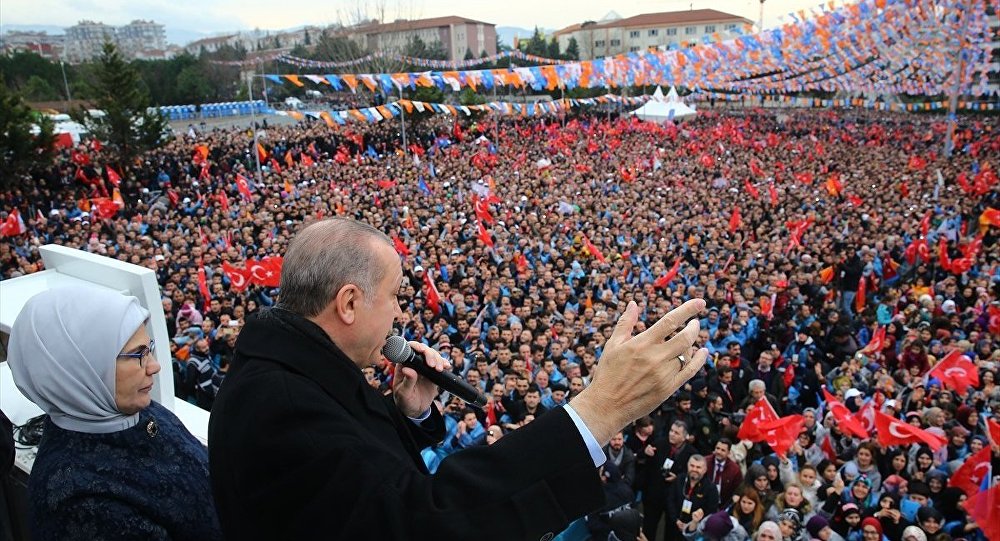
[279,94,649,127]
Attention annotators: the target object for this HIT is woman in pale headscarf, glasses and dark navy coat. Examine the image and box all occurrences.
[7,287,222,541]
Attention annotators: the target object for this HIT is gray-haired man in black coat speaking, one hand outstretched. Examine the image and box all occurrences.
[209,218,707,540]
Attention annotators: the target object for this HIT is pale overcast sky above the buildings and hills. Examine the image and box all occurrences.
[0,0,820,33]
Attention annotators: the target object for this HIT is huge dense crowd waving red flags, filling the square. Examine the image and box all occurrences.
[0,102,1000,541]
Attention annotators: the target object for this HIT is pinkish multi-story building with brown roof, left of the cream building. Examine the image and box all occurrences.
[344,16,497,61]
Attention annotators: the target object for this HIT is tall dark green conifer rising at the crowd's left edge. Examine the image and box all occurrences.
[74,41,167,167]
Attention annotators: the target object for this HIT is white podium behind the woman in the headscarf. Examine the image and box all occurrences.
[0,244,208,473]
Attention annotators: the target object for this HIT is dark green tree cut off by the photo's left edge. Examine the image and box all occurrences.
[0,79,55,189]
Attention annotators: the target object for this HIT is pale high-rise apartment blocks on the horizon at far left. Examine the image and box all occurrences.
[65,20,167,63]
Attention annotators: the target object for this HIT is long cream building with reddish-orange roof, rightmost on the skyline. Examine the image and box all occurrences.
[555,9,753,60]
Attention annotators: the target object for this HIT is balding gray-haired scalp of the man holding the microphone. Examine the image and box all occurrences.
[281,218,392,317]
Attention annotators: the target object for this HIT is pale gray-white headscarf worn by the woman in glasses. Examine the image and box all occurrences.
[7,286,149,434]
